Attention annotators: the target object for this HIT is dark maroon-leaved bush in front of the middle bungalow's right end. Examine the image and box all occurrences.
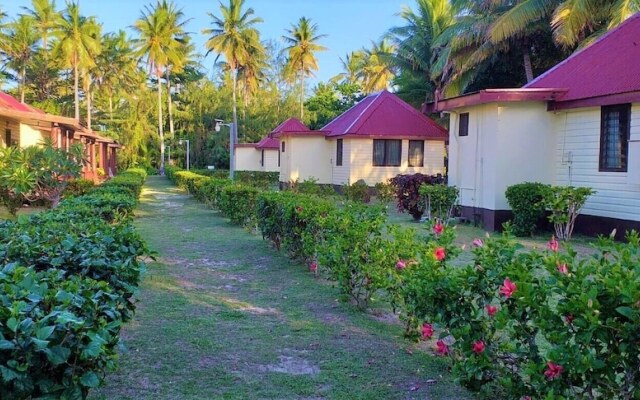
[389,174,445,221]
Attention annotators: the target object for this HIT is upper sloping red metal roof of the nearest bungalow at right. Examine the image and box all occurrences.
[524,13,640,102]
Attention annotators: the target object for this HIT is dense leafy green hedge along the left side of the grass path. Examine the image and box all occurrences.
[0,170,148,399]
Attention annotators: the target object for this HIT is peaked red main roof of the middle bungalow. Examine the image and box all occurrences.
[322,90,448,140]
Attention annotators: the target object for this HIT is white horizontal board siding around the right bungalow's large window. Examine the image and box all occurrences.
[555,104,640,221]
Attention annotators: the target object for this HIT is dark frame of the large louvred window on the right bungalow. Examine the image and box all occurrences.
[598,104,631,172]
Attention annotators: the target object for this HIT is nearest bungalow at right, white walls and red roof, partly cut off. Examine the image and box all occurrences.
[427,14,640,234]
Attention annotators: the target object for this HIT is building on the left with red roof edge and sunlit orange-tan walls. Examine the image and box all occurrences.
[0,92,121,180]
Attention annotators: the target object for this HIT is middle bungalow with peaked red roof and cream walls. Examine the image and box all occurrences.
[262,91,447,186]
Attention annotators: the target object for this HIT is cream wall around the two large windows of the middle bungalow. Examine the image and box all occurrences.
[349,139,444,186]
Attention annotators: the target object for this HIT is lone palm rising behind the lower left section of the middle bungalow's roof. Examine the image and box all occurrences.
[282,17,327,119]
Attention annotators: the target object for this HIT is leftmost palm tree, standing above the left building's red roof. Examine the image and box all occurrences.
[0,15,38,103]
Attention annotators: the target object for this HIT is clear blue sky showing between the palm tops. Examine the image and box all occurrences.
[0,0,414,82]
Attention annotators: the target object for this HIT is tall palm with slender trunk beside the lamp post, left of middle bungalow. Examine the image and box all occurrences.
[202,0,262,148]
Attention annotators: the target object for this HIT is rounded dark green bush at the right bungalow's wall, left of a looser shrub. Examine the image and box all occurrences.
[505,182,549,236]
